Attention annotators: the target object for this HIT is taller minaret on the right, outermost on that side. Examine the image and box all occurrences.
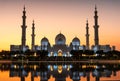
[94,5,99,45]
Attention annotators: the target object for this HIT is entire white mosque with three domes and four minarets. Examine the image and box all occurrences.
[10,6,115,56]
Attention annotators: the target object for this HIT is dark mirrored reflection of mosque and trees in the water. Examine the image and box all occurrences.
[0,63,120,81]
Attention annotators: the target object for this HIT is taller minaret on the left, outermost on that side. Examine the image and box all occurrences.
[21,6,27,49]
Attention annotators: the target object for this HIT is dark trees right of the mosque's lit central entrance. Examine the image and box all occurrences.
[70,50,120,60]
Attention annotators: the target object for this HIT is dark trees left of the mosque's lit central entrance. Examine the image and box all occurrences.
[0,50,48,61]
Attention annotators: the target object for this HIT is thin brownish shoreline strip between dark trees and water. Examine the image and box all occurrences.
[0,59,120,64]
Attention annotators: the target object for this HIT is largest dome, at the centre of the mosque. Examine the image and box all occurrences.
[55,33,66,45]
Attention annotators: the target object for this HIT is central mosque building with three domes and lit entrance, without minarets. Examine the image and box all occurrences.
[35,33,85,56]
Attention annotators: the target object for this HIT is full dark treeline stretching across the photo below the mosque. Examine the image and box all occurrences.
[0,50,120,61]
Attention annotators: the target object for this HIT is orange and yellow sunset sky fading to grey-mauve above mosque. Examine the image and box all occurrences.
[0,0,120,50]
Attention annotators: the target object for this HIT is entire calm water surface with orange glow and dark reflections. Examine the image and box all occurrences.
[0,62,120,81]
